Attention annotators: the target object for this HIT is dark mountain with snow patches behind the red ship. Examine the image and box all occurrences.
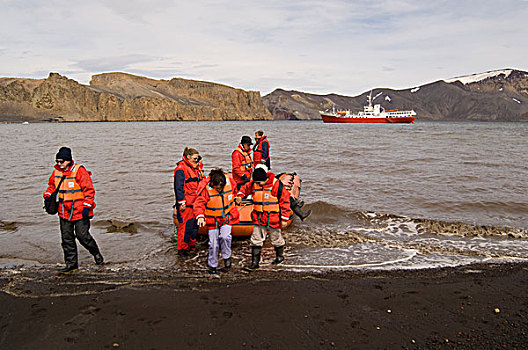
[263,69,528,121]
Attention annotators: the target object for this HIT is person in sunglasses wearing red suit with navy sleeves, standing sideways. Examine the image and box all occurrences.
[174,147,204,256]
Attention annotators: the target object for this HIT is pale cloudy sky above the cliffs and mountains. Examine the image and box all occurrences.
[0,0,528,96]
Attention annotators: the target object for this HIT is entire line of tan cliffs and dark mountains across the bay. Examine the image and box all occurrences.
[0,69,528,122]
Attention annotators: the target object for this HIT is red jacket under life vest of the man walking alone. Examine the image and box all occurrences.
[44,161,95,221]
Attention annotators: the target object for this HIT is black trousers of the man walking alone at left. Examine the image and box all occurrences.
[59,217,99,267]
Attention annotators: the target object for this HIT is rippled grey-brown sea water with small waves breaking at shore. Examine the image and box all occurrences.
[0,121,528,271]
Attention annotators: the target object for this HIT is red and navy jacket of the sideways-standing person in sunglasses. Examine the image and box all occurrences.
[174,157,203,206]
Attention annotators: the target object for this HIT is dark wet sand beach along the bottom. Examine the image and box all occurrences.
[0,264,528,349]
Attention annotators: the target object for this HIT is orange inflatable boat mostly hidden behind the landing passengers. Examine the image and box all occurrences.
[173,173,301,237]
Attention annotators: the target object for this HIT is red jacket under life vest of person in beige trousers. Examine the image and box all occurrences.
[237,173,291,228]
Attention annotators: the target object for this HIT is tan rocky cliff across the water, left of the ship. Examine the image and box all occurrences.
[0,73,272,121]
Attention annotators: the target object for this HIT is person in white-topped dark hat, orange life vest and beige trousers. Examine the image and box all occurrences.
[236,165,291,270]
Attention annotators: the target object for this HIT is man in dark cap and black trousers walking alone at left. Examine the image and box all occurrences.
[44,147,103,273]
